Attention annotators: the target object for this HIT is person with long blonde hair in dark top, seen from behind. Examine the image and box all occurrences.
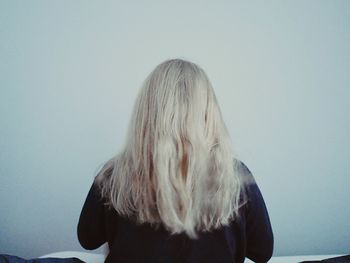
[78,59,273,263]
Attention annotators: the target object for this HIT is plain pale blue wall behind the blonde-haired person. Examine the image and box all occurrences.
[0,0,350,258]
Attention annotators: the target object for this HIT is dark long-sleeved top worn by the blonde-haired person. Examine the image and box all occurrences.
[78,161,273,263]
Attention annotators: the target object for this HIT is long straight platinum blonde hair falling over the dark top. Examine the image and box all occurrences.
[96,59,241,238]
